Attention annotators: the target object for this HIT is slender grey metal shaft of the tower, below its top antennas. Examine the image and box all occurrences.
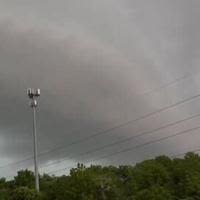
[32,100,40,192]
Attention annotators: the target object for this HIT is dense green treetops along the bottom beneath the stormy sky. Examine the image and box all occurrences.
[0,153,200,200]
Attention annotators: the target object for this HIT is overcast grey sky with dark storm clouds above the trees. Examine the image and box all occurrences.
[0,0,200,176]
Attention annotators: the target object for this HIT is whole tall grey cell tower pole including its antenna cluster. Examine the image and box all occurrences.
[27,88,40,192]
